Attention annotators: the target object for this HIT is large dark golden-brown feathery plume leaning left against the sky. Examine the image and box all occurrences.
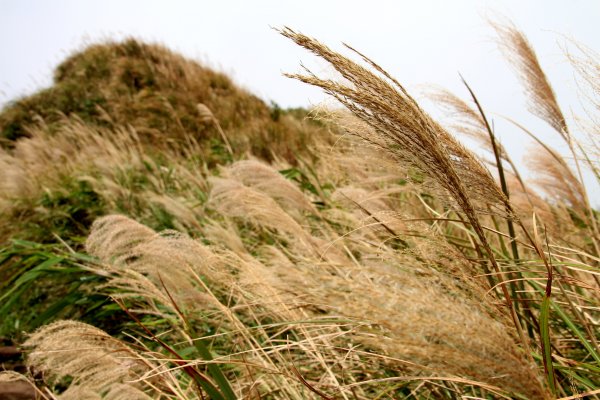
[280,27,529,378]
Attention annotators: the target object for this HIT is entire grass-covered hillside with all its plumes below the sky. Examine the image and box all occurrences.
[0,27,600,400]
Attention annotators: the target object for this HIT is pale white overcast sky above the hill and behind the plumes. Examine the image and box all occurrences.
[0,0,600,207]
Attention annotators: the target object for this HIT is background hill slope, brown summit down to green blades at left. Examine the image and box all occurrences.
[0,40,325,341]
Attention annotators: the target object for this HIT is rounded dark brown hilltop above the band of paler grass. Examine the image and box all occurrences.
[0,39,324,161]
